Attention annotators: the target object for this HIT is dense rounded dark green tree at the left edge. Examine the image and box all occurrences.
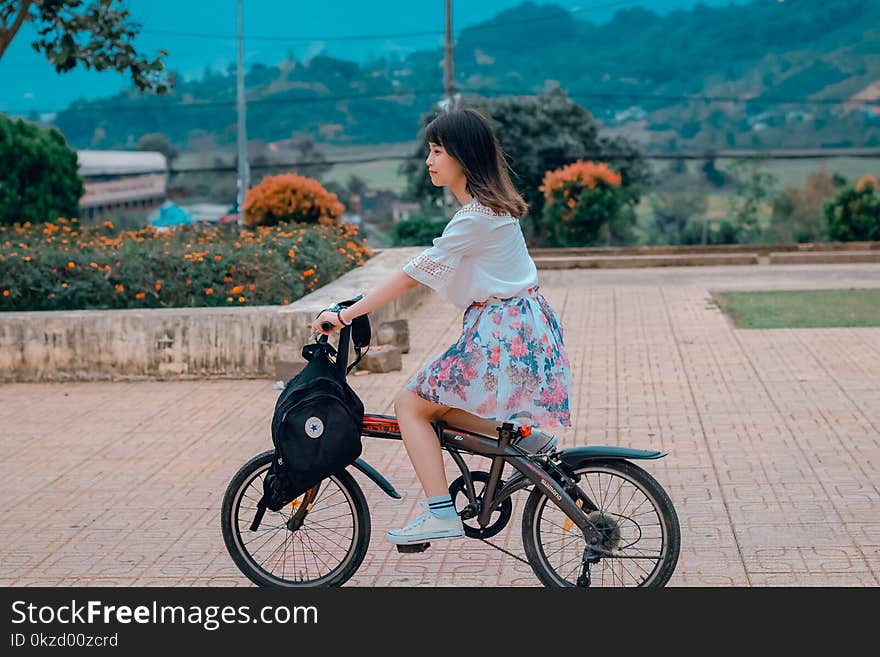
[0,114,84,224]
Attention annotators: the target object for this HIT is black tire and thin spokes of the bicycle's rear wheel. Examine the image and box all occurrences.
[522,459,681,588]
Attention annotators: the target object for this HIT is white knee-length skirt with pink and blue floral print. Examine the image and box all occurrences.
[406,286,571,427]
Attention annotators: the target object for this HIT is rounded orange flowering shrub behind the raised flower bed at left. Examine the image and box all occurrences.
[244,173,345,226]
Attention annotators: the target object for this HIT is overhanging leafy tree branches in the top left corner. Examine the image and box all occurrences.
[0,0,173,94]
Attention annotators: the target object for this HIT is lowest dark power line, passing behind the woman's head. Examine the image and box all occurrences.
[168,148,880,175]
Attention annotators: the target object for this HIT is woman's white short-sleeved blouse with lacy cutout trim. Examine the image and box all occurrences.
[403,199,538,308]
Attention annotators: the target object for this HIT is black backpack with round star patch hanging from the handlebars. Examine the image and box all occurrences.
[251,297,370,531]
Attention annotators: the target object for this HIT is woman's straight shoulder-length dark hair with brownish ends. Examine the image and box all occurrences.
[425,107,529,217]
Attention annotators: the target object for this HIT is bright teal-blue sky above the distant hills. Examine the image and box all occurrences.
[0,0,730,113]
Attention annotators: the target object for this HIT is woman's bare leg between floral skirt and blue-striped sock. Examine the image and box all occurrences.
[394,389,450,497]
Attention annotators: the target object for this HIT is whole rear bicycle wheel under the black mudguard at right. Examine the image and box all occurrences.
[522,460,681,587]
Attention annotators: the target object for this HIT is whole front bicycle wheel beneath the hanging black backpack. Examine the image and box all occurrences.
[221,451,370,588]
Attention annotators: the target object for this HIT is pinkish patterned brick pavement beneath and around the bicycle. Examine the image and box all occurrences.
[0,264,880,586]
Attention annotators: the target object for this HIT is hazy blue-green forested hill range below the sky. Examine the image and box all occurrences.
[49,0,880,150]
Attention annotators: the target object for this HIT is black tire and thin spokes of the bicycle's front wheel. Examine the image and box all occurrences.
[220,450,371,588]
